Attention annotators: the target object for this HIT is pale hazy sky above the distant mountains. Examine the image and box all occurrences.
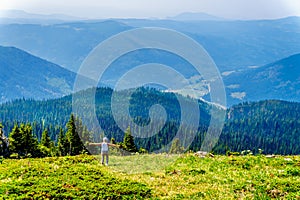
[0,0,300,19]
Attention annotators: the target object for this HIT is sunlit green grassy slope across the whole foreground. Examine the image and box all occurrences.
[0,155,300,199]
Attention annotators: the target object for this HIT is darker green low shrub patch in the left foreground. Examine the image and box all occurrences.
[0,156,151,199]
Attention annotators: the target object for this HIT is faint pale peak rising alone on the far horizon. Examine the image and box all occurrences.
[168,12,225,21]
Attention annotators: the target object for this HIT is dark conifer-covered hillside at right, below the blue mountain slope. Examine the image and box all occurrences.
[216,100,300,154]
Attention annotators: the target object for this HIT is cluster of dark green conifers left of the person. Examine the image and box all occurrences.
[1,114,85,158]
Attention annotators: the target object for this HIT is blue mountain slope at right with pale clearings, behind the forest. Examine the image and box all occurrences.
[224,54,300,104]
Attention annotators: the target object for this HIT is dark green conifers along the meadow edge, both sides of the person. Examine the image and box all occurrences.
[0,114,141,158]
